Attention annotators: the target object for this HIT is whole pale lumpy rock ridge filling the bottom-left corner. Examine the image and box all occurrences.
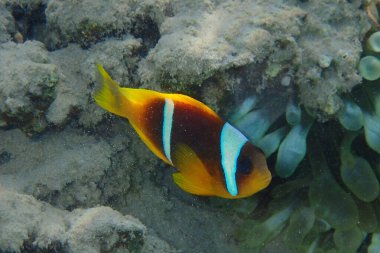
[0,189,174,253]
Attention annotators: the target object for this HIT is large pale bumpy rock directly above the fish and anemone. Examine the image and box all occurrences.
[139,0,370,116]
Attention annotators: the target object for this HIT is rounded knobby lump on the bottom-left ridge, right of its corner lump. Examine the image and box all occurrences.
[66,207,146,253]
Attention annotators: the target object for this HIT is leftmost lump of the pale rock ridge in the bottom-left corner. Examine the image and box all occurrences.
[0,188,68,252]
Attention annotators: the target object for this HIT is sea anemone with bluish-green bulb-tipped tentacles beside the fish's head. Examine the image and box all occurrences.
[231,32,380,253]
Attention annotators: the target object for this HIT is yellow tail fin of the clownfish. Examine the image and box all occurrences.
[94,64,130,118]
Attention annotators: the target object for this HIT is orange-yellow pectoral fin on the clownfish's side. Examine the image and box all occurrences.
[172,144,216,196]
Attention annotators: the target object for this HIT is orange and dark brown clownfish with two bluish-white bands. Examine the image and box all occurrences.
[94,64,271,199]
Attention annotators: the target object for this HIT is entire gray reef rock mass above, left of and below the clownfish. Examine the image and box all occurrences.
[0,0,369,253]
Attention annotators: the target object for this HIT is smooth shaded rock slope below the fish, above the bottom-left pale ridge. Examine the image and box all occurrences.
[0,121,236,252]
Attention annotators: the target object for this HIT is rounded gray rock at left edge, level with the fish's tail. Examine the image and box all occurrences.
[0,41,59,132]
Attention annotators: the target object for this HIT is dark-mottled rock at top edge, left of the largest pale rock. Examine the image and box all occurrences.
[45,0,169,48]
